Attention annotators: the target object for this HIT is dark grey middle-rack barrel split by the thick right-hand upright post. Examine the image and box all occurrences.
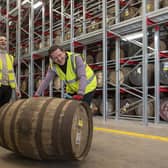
[128,64,154,86]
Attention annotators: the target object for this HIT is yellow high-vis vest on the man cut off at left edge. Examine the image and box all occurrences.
[0,54,16,88]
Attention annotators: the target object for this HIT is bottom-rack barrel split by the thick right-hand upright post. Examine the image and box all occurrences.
[135,101,154,117]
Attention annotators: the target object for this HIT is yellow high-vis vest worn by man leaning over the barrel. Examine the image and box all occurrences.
[50,52,97,94]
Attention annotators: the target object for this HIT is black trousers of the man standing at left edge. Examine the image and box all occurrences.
[0,85,12,107]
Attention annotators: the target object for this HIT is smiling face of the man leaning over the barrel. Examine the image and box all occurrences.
[51,49,66,65]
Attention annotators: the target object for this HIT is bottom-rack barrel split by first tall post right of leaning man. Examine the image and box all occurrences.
[100,98,115,116]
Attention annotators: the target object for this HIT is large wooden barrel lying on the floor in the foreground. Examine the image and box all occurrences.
[0,97,93,160]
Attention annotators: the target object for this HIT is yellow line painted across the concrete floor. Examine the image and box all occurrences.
[94,127,168,142]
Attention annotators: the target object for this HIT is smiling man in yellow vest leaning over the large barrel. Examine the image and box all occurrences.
[34,45,97,105]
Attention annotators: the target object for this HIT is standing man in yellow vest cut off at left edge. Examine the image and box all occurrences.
[0,35,21,107]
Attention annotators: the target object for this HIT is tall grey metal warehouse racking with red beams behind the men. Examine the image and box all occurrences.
[0,0,168,125]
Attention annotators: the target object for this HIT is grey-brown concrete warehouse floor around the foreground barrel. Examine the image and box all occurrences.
[0,117,168,168]
